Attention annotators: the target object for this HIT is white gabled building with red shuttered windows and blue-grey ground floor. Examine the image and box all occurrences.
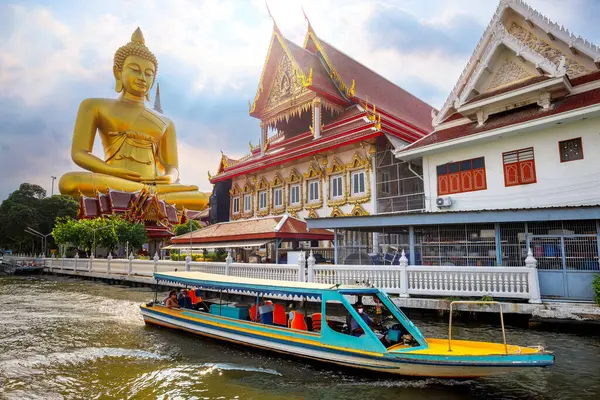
[308,0,600,300]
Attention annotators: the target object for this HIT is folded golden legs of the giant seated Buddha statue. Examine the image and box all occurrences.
[58,172,210,210]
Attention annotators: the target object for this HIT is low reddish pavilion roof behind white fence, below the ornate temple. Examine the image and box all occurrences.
[171,216,333,243]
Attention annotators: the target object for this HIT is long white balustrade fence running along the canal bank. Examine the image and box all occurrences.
[5,251,541,303]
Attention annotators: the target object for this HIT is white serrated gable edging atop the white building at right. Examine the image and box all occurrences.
[432,0,600,126]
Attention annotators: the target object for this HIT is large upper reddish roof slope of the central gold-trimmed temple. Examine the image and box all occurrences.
[320,40,434,132]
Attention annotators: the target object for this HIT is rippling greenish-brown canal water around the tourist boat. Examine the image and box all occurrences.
[0,276,600,400]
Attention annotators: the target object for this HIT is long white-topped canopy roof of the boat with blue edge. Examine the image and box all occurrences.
[154,271,379,298]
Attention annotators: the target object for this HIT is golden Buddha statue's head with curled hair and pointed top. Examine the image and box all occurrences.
[113,28,158,98]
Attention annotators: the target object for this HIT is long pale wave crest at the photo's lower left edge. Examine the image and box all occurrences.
[0,347,168,378]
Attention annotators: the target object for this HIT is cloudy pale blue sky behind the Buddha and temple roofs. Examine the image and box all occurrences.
[0,0,600,200]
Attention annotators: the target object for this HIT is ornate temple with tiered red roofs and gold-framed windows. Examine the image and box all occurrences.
[209,16,433,228]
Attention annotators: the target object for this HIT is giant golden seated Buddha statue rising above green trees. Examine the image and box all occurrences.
[58,28,210,210]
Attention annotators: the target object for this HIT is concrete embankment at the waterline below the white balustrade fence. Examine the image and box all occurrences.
[46,269,600,325]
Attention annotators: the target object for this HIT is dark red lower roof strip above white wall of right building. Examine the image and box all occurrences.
[400,89,600,154]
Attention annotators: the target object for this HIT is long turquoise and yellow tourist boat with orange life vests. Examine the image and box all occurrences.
[141,272,554,378]
